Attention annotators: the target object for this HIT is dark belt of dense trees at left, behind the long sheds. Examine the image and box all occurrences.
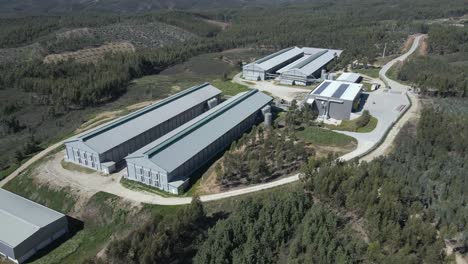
[0,38,234,106]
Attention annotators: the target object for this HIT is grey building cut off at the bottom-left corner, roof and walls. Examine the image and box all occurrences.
[0,189,68,263]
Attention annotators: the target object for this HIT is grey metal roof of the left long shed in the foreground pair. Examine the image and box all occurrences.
[67,83,221,153]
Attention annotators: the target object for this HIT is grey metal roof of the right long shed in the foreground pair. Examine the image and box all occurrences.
[126,90,272,172]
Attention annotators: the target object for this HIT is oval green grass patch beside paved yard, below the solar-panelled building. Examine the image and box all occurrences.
[296,127,357,147]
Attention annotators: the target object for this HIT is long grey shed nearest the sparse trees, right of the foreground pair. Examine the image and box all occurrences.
[125,90,273,194]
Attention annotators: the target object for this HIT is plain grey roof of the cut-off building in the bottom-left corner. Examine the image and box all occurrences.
[0,189,65,247]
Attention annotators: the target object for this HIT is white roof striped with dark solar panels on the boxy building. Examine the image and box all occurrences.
[310,80,362,101]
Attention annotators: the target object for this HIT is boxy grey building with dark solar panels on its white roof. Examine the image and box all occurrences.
[306,80,362,120]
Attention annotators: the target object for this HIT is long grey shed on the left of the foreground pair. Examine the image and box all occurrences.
[65,83,221,173]
